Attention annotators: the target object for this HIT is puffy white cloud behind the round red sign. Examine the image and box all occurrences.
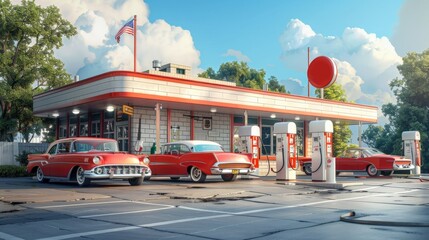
[280,19,402,106]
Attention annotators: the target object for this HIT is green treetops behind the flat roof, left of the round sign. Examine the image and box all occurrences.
[198,61,286,93]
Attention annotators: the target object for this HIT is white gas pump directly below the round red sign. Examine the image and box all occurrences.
[309,120,335,183]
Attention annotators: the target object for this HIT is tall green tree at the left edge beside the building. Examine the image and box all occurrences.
[0,0,77,141]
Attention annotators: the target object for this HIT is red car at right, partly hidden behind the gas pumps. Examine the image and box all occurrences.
[300,148,414,177]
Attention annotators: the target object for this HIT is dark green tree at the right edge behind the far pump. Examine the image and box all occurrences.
[364,50,429,172]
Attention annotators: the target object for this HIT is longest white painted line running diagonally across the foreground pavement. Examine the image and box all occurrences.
[32,189,419,240]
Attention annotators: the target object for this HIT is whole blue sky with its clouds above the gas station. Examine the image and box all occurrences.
[12,0,429,123]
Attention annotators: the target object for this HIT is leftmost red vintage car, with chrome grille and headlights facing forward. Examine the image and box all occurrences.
[27,137,148,186]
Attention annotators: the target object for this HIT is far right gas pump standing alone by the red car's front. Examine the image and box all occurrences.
[402,131,422,175]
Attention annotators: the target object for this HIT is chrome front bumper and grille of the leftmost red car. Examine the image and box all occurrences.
[84,165,150,179]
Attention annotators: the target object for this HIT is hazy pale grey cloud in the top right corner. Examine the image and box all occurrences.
[392,0,429,56]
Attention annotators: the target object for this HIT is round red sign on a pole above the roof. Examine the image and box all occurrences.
[307,56,338,88]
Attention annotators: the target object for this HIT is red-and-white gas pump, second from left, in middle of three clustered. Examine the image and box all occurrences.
[272,122,297,181]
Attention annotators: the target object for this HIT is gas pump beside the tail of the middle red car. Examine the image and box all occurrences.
[238,126,261,174]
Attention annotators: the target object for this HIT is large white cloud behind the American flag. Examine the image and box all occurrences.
[12,0,201,79]
